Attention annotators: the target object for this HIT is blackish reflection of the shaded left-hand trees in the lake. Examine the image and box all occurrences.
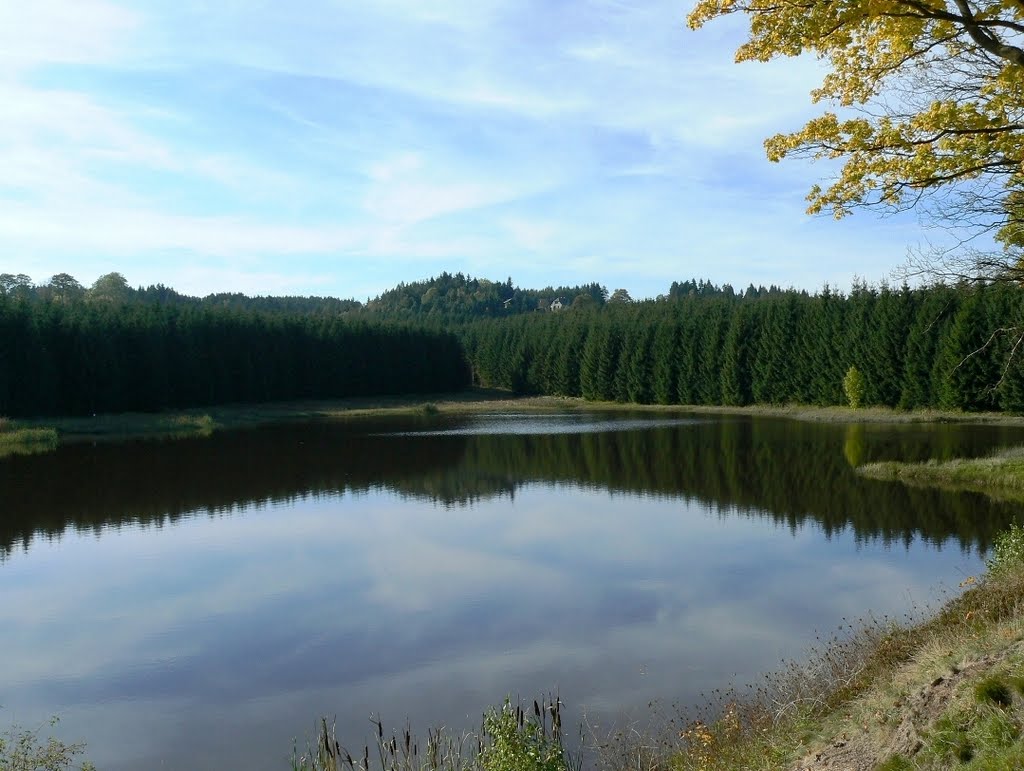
[0,422,464,556]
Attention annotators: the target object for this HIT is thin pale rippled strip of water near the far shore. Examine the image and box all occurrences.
[382,413,707,436]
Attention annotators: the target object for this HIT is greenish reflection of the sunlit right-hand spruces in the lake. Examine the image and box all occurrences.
[434,418,1018,549]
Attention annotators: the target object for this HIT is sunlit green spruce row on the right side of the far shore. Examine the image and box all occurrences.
[463,284,1024,412]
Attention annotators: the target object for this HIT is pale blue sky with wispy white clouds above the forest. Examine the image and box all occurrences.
[0,0,924,300]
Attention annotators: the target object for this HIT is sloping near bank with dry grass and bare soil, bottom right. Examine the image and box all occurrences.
[612,528,1024,771]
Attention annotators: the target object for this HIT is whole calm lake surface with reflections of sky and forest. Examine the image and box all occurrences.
[0,413,1024,769]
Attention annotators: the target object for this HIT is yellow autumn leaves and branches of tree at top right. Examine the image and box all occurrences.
[688,0,1024,280]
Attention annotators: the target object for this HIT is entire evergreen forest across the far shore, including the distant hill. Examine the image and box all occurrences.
[8,273,1024,416]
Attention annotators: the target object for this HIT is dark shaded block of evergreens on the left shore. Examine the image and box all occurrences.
[0,296,468,417]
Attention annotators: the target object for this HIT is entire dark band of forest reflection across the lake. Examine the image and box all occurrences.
[0,418,1018,553]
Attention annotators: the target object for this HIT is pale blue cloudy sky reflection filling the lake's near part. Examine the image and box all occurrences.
[0,485,978,768]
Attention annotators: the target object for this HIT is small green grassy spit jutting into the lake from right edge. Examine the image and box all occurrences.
[857,447,1024,502]
